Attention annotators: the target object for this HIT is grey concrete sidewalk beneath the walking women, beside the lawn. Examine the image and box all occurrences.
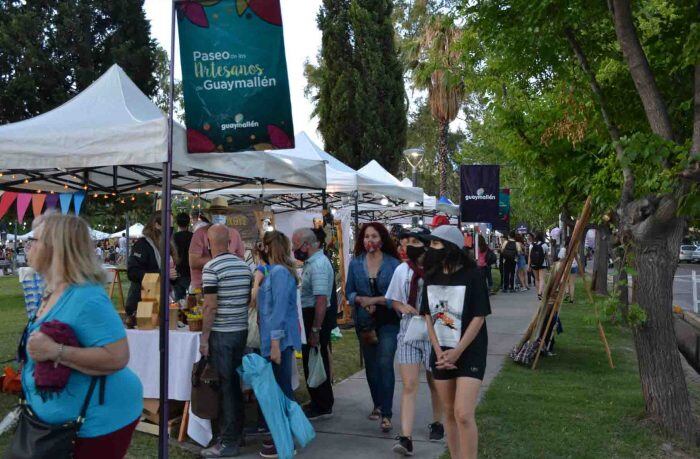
[241,289,537,459]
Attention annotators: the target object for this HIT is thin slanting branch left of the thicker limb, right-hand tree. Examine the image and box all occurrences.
[564,27,634,207]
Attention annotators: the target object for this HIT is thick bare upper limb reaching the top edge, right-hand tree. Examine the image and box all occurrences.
[608,0,674,140]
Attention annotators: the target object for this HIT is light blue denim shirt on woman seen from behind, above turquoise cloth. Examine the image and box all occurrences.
[258,265,301,357]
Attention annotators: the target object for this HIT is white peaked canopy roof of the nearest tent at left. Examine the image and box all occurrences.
[0,65,326,193]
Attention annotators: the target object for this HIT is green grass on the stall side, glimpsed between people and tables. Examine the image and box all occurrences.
[0,276,360,459]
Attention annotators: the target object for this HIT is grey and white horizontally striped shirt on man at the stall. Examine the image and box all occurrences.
[202,253,253,332]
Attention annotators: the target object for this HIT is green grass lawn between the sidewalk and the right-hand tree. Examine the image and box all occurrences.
[470,285,700,458]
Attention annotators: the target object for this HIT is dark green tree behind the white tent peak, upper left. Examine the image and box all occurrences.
[0,0,156,122]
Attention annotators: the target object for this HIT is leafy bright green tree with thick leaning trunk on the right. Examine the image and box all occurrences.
[462,0,700,442]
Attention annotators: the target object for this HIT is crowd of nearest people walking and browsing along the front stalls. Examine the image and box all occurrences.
[15,202,492,458]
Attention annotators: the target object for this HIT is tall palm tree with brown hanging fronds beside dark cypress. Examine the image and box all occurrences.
[406,14,465,196]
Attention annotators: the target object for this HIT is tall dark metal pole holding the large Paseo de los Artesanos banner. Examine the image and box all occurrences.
[158,2,175,459]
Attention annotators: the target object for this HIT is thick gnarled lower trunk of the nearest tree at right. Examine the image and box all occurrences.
[621,195,698,444]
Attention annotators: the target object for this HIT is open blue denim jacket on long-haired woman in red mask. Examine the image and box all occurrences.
[345,253,401,325]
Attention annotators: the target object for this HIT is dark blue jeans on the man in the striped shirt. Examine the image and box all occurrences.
[209,330,248,445]
